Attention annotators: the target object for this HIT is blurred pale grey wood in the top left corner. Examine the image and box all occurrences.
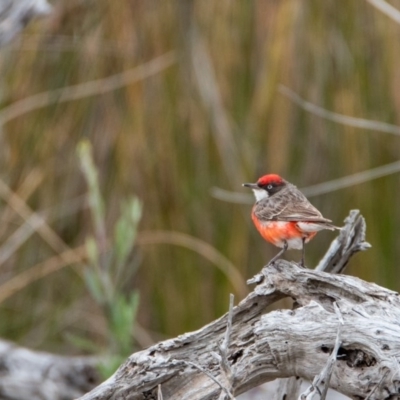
[0,0,51,46]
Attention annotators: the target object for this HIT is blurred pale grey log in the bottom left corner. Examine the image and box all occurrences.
[0,340,99,400]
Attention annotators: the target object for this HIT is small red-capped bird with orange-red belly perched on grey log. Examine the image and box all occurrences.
[243,174,340,267]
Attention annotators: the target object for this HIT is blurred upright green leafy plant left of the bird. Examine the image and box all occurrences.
[74,140,142,378]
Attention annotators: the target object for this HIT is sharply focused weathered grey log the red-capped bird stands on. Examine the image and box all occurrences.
[77,212,400,400]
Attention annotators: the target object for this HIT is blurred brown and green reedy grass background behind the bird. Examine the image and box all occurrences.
[0,0,400,353]
